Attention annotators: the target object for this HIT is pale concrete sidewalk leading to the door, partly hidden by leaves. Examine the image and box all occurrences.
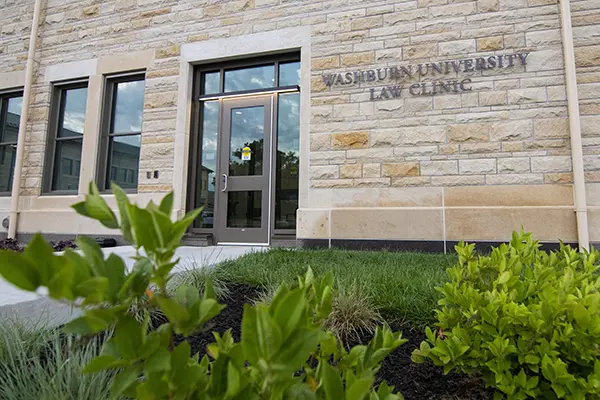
[0,246,268,326]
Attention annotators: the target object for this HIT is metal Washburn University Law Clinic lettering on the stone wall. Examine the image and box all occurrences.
[322,53,529,100]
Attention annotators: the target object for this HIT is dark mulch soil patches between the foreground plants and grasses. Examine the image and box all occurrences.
[155,285,493,400]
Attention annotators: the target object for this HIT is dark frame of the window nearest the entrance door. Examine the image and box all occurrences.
[96,70,146,194]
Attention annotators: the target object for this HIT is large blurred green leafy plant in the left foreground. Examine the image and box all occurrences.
[0,184,405,400]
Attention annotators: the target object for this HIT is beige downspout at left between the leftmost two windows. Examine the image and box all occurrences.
[8,0,42,238]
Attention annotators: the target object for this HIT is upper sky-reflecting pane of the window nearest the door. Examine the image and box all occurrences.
[110,79,144,133]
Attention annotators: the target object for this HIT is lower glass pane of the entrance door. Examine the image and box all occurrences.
[227,190,262,228]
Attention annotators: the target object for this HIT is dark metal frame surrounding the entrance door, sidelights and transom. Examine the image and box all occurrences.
[186,50,301,237]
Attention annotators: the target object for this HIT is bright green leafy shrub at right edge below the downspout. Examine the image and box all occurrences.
[413,232,600,399]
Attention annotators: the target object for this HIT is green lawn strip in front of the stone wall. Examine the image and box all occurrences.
[214,249,456,326]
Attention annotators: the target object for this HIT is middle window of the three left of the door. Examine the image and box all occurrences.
[44,81,88,194]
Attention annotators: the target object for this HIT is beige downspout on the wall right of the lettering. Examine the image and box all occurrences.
[560,0,590,250]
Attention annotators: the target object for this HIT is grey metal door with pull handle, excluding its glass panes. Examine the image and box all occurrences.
[214,93,276,246]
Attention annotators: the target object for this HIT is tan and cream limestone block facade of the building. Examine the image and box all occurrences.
[0,0,600,251]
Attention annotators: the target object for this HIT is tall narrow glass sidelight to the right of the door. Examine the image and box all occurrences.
[275,93,300,229]
